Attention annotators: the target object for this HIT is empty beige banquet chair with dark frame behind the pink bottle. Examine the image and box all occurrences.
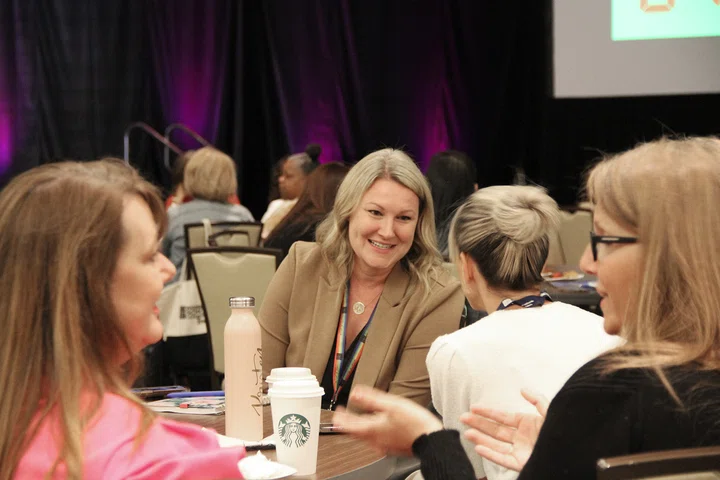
[188,247,282,389]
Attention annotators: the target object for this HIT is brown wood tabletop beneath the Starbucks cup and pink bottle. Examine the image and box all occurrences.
[162,406,397,480]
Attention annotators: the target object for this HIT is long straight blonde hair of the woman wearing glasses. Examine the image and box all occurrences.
[587,137,720,403]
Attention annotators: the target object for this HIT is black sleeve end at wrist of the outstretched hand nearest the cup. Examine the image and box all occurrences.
[412,430,477,480]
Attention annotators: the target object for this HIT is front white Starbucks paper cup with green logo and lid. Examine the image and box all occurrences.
[268,378,325,475]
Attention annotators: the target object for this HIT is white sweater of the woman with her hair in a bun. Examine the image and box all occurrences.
[426,302,622,480]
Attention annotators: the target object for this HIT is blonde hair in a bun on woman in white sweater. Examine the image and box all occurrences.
[449,185,560,291]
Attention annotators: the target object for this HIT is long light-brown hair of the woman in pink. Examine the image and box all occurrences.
[0,160,165,480]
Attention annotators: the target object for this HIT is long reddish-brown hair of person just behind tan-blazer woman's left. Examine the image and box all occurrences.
[266,162,350,242]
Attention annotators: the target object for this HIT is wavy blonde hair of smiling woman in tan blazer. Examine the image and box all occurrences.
[316,148,441,289]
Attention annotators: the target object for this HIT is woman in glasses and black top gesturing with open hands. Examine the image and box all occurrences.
[335,138,720,480]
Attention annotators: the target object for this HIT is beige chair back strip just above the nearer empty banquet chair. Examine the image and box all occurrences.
[185,222,262,250]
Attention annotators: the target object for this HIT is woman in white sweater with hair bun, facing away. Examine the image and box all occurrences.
[427,186,621,480]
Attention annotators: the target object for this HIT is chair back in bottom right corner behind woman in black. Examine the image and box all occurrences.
[597,446,720,480]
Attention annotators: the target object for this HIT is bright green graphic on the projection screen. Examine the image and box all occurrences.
[611,0,720,41]
